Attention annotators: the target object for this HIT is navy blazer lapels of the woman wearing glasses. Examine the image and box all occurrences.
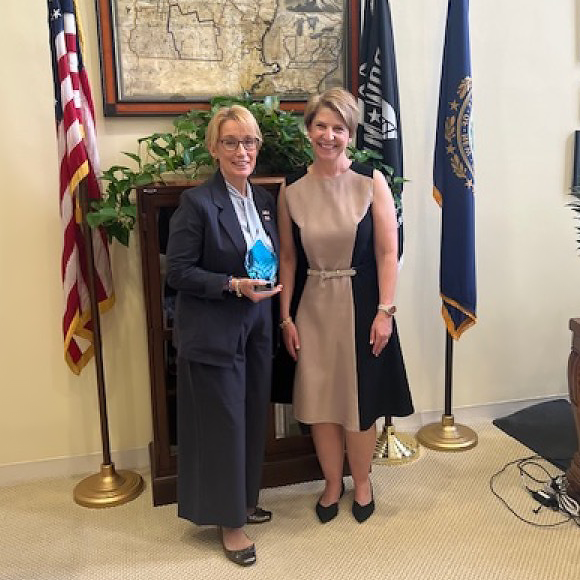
[209,170,278,260]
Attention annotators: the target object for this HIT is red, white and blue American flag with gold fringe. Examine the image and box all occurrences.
[48,0,114,374]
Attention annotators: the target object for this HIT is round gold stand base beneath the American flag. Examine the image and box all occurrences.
[74,463,143,508]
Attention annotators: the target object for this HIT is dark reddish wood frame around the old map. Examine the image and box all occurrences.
[95,0,360,117]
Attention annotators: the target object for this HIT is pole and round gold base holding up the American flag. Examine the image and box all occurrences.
[73,179,143,508]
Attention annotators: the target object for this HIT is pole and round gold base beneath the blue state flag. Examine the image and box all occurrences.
[417,332,477,451]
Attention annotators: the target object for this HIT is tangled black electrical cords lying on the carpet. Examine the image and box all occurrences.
[489,455,580,528]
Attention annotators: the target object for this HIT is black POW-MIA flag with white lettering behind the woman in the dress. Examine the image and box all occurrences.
[357,0,403,259]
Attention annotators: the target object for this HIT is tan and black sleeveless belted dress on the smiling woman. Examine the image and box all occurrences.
[286,163,412,431]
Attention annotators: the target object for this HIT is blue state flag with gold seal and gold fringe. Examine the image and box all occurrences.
[433,0,477,339]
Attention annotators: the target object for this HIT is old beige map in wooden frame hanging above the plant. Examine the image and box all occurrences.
[97,0,360,116]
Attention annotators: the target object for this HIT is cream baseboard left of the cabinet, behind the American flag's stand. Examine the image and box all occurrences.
[0,447,149,486]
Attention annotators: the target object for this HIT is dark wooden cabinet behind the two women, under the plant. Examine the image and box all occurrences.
[137,177,322,505]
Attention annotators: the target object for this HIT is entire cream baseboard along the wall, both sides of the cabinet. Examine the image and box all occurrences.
[0,393,568,486]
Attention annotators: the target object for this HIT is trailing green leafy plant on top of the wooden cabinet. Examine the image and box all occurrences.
[87,95,405,246]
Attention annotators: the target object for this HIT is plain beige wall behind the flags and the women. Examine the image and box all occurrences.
[0,0,580,465]
